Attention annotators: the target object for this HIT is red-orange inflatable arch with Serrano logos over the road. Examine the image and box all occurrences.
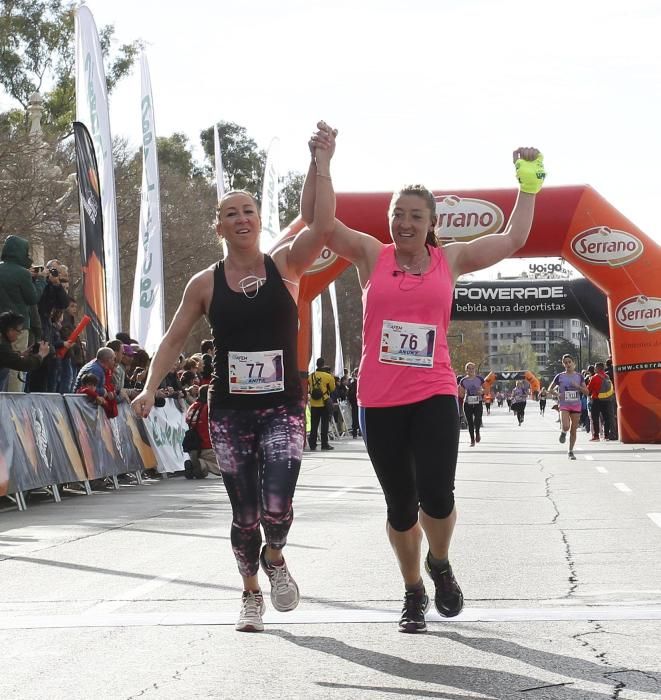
[275,185,661,443]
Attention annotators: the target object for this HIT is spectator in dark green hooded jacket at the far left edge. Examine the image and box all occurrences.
[0,236,41,391]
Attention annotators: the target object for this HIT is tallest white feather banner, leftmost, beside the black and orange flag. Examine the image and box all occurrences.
[75,5,122,337]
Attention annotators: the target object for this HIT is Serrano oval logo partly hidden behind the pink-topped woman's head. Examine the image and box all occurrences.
[436,194,505,241]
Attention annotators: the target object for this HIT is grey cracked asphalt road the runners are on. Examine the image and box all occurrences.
[0,404,661,700]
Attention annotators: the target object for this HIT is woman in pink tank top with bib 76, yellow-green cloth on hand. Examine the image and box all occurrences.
[301,123,545,633]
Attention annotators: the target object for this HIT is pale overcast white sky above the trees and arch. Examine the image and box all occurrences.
[10,0,661,274]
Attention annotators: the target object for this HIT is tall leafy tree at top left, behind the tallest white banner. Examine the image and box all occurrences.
[0,0,142,138]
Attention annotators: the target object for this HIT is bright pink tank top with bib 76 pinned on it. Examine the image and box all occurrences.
[358,244,457,408]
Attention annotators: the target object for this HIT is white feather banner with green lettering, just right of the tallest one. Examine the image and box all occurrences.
[131,53,165,355]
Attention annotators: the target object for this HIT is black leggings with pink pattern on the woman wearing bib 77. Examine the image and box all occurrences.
[209,404,305,577]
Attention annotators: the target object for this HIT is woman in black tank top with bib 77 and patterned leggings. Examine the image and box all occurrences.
[133,122,334,632]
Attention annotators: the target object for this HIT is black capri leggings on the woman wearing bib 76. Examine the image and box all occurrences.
[360,395,459,532]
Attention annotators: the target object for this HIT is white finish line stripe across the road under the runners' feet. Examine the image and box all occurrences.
[0,605,661,630]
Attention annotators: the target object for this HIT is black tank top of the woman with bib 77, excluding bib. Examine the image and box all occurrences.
[209,255,302,410]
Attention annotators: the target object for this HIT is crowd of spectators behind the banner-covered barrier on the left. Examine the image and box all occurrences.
[0,236,213,418]
